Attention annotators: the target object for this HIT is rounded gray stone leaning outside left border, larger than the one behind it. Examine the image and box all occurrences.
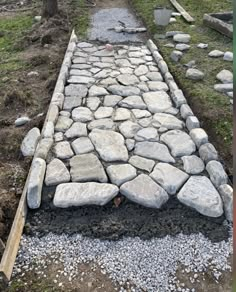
[20,127,40,156]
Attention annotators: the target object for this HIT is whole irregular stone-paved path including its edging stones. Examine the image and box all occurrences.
[24,37,232,217]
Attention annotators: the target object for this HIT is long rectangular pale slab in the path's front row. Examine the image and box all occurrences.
[53,182,119,208]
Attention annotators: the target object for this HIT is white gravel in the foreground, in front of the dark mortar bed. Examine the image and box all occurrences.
[14,227,233,292]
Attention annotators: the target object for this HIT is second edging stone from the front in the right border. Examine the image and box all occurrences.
[206,160,228,188]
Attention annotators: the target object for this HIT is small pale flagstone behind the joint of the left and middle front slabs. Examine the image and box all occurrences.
[106,164,137,186]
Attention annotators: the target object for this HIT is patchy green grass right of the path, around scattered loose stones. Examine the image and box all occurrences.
[130,0,233,168]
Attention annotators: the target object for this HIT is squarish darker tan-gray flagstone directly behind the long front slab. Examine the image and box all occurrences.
[70,153,108,183]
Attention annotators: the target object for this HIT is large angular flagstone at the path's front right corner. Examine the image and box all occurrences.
[177,176,223,217]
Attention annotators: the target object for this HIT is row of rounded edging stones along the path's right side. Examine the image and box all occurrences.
[147,39,233,222]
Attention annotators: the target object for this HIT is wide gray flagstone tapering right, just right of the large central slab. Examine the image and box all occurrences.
[134,141,175,163]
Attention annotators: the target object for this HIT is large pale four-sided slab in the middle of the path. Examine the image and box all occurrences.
[89,129,128,162]
